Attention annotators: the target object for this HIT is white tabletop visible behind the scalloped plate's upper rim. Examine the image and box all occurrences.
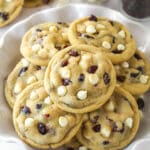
[0,0,150,37]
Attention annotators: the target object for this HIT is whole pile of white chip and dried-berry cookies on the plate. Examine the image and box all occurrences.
[5,15,150,150]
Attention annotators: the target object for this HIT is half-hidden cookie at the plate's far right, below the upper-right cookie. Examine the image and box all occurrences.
[115,50,150,95]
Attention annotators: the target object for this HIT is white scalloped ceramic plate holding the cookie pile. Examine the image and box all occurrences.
[0,4,150,150]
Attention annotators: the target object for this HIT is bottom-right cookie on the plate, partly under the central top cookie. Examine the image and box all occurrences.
[77,87,140,150]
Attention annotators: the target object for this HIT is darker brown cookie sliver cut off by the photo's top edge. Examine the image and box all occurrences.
[23,0,50,8]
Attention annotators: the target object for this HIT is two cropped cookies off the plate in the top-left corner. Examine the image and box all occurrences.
[0,0,50,27]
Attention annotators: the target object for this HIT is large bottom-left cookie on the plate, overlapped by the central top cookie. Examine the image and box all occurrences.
[13,82,82,149]
